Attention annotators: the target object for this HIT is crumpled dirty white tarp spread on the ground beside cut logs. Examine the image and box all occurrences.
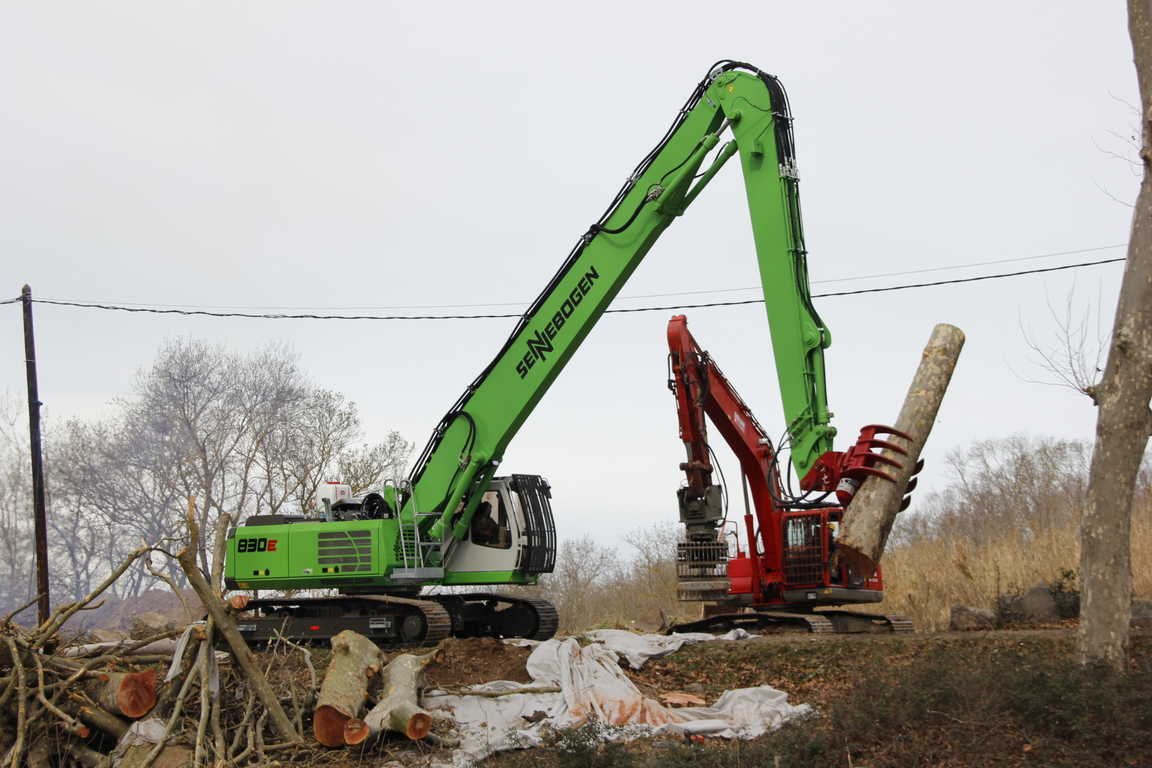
[424,630,809,768]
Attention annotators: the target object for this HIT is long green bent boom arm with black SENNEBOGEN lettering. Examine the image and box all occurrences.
[402,62,835,550]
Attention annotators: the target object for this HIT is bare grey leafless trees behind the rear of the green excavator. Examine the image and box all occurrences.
[22,340,411,596]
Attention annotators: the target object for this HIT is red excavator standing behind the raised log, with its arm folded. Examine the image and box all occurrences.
[668,315,920,633]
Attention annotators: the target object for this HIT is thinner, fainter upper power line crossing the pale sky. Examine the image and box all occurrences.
[20,243,1128,317]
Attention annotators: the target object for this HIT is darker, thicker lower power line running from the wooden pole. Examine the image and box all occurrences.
[9,257,1127,320]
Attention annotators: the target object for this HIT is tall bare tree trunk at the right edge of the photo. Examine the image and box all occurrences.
[1079,0,1152,669]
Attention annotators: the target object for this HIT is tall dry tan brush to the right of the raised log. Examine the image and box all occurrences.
[882,436,1152,630]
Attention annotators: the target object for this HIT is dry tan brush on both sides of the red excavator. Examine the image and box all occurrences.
[535,435,1152,632]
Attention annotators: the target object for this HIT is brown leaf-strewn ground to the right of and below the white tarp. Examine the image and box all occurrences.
[484,626,1152,768]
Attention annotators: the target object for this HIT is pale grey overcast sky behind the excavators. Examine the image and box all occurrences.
[0,0,1138,542]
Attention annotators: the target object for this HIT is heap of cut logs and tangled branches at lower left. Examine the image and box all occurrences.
[0,495,458,768]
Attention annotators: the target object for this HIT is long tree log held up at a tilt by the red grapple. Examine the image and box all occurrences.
[836,324,964,578]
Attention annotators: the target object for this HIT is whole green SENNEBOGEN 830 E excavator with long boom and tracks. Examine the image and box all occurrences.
[226,61,907,645]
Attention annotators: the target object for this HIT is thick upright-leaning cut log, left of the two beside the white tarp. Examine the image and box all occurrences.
[312,630,382,746]
